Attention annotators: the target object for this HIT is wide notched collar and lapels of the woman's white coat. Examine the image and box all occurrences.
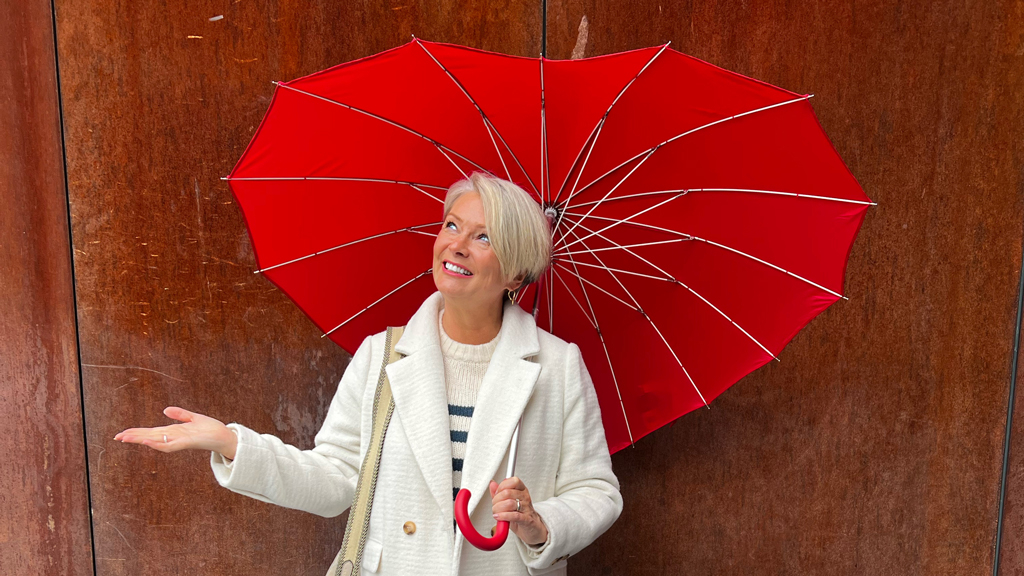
[386,292,541,522]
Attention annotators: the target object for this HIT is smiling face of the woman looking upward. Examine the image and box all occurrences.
[433,192,516,305]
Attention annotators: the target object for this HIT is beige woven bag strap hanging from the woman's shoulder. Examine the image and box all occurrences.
[327,326,404,576]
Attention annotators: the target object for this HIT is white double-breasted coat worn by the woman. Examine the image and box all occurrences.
[211,292,623,576]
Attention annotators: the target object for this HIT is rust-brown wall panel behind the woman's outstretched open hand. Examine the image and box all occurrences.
[56,0,541,575]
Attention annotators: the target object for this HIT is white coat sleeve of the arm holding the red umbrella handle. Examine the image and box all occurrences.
[515,343,623,574]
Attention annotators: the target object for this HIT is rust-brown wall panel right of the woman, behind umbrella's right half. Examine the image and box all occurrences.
[548,0,1024,574]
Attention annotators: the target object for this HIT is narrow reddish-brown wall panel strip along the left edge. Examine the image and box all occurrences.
[0,0,92,576]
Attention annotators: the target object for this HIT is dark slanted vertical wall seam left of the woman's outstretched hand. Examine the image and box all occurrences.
[50,0,97,576]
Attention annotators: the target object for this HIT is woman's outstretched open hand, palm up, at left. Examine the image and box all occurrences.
[114,406,239,460]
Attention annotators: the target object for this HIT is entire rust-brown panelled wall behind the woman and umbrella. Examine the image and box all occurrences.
[0,0,1024,576]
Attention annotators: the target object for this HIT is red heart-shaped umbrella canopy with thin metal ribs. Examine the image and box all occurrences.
[227,39,871,452]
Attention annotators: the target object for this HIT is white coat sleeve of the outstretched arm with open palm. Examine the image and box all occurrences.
[210,337,372,518]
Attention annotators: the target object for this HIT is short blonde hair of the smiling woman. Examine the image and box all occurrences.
[443,172,551,286]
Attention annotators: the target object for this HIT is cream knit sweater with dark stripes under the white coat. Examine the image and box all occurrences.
[437,308,501,500]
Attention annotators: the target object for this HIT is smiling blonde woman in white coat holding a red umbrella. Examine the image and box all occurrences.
[115,173,623,575]
